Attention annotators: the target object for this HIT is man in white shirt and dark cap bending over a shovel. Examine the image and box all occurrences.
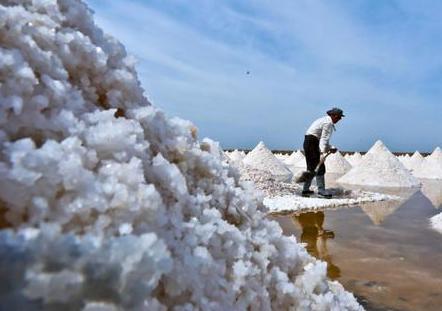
[302,108,344,198]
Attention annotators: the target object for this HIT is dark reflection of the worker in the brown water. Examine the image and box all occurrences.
[293,212,341,279]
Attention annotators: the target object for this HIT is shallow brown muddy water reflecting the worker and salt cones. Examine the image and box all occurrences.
[273,191,442,311]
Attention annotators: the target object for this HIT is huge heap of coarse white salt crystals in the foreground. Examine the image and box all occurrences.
[0,0,362,310]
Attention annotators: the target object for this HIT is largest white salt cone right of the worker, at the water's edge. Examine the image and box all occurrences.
[337,140,419,188]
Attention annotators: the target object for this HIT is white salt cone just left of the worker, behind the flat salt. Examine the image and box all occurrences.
[243,141,292,182]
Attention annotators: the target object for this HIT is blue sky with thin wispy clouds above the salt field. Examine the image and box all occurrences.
[86,0,442,152]
